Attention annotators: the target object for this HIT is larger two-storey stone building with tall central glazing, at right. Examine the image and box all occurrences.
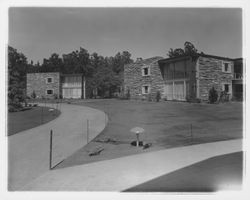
[124,54,243,101]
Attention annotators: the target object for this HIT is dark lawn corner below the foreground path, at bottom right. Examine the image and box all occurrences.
[126,152,243,192]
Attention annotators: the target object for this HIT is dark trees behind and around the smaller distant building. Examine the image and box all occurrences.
[8,46,133,109]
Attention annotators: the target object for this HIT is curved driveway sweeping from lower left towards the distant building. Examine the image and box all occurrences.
[8,104,107,190]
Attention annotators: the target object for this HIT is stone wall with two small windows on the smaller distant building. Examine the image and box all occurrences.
[26,72,60,98]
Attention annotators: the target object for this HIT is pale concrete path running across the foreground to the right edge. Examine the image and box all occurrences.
[22,139,242,191]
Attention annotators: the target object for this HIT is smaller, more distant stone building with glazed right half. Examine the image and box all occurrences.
[26,72,85,98]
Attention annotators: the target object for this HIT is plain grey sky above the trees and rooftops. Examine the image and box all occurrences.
[9,7,242,63]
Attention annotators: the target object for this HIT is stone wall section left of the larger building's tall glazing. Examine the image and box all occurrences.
[124,57,164,99]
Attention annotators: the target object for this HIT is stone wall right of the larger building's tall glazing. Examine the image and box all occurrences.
[197,56,234,101]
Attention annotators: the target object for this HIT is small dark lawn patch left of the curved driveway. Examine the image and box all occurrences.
[8,107,60,136]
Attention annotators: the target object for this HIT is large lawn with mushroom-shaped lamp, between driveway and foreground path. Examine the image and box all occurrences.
[58,99,243,168]
